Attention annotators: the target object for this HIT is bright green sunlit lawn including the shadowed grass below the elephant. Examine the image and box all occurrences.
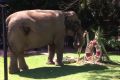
[0,53,120,80]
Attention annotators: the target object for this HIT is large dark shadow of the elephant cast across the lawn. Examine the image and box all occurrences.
[18,64,107,79]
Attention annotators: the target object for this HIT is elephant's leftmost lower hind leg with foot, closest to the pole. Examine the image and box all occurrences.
[9,52,20,74]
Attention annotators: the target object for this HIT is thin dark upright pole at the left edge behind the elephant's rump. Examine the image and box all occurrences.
[0,4,8,80]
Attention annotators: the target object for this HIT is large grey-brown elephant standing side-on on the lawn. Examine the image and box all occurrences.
[6,9,83,74]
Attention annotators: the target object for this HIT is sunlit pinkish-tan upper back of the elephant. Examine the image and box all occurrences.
[6,10,64,29]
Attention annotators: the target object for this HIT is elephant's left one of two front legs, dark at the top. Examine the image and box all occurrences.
[47,44,55,64]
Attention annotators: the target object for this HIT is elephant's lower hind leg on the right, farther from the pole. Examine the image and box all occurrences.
[18,52,28,70]
